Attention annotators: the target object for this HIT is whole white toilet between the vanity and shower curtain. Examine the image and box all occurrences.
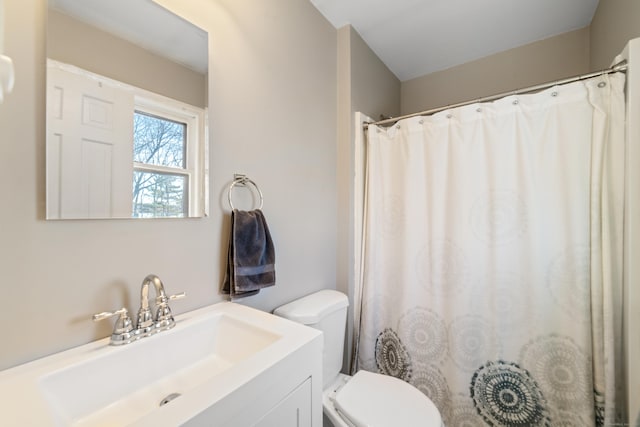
[273,290,443,427]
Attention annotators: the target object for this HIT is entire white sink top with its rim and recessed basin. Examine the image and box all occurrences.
[0,302,318,427]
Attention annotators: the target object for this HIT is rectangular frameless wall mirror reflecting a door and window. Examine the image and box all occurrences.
[46,0,208,219]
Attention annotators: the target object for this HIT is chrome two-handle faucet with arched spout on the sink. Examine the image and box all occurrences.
[93,274,185,345]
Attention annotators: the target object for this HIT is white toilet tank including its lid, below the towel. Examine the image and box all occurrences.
[273,289,349,388]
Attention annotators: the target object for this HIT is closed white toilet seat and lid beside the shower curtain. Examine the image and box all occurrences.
[334,371,442,427]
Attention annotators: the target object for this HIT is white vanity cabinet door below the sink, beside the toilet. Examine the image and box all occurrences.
[254,378,311,427]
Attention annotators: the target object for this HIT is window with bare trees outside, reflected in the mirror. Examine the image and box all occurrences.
[132,99,198,218]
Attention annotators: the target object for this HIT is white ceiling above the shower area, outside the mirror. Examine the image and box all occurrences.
[311,0,598,81]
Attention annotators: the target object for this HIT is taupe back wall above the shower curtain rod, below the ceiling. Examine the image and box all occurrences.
[401,27,589,114]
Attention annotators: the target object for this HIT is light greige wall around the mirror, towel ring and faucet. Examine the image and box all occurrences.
[0,0,337,369]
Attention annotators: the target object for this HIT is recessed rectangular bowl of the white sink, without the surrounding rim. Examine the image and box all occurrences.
[40,312,281,426]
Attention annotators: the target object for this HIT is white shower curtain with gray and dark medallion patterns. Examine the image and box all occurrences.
[357,73,625,427]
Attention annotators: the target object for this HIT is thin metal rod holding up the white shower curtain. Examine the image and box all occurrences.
[363,60,628,130]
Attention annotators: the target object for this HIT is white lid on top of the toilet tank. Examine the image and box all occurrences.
[273,289,349,325]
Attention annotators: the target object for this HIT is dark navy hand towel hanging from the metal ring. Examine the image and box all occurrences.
[222,209,276,298]
